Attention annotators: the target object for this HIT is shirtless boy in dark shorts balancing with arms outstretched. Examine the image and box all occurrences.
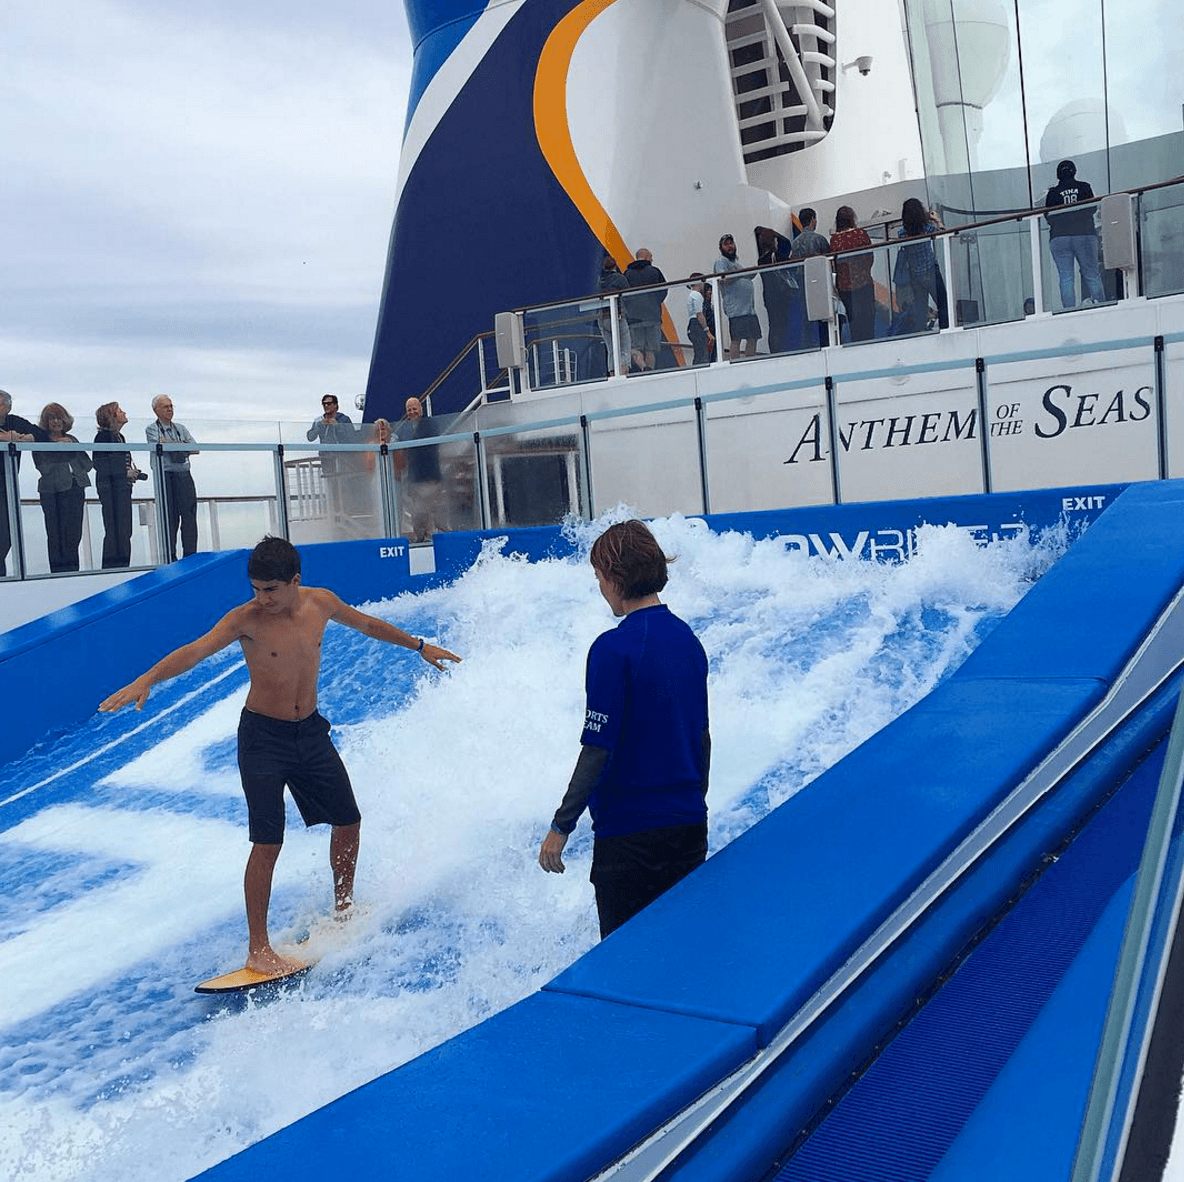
[98,538,461,975]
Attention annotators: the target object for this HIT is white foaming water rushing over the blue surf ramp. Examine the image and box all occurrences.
[0,513,1063,1182]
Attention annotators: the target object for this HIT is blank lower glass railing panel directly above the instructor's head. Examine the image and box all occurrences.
[590,406,702,516]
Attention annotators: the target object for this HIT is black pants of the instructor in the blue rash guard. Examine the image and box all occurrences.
[590,821,707,939]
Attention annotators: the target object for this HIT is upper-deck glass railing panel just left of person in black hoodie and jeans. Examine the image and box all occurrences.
[937,220,1035,328]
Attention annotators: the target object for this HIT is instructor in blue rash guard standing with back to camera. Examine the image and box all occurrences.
[539,521,712,939]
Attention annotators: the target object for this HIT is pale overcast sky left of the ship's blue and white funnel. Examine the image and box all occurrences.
[0,0,411,429]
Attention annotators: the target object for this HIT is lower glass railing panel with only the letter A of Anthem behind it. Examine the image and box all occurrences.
[704,387,834,513]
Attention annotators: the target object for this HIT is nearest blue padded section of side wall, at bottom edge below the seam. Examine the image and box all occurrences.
[189,994,755,1182]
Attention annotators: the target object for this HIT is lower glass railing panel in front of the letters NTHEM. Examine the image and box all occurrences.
[824,370,983,501]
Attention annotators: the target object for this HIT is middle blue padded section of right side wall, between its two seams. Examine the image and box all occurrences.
[545,679,1103,1043]
